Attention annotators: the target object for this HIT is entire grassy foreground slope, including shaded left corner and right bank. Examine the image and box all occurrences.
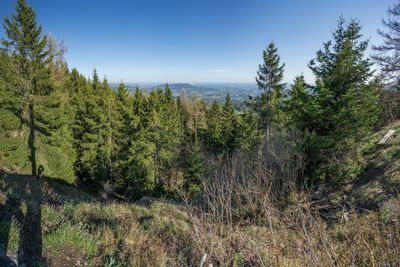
[0,123,400,266]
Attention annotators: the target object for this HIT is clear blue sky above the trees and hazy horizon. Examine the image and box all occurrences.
[0,0,396,82]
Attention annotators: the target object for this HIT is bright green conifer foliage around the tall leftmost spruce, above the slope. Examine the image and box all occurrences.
[0,0,75,182]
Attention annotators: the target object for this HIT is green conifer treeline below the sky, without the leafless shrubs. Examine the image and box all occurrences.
[0,0,399,199]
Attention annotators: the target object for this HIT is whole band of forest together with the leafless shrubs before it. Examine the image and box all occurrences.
[0,0,400,266]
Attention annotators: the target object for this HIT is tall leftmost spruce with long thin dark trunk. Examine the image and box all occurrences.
[2,0,51,176]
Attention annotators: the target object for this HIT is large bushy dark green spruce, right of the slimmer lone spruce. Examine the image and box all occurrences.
[306,18,379,182]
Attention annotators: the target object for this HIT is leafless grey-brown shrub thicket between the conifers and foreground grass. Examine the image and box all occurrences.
[202,127,304,226]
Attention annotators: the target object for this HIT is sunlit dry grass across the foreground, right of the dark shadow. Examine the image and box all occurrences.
[0,185,400,266]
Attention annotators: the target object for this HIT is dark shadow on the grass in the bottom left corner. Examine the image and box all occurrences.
[0,170,91,267]
